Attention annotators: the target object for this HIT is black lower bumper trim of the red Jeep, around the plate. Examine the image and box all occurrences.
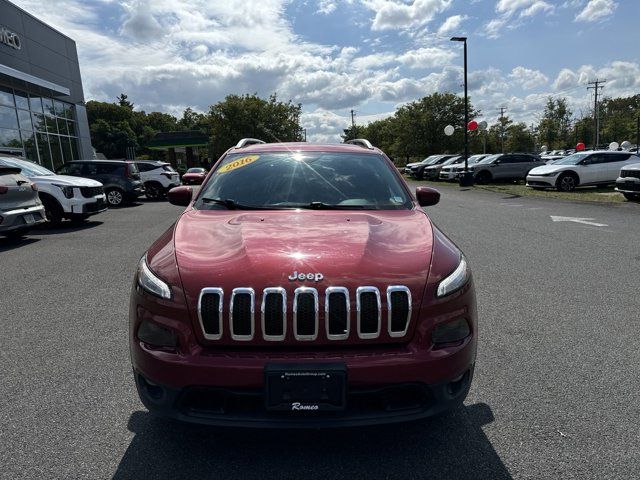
[134,365,474,428]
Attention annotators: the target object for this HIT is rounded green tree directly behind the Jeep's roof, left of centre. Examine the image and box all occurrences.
[209,94,302,158]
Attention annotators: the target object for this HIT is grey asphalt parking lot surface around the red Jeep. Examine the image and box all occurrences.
[0,189,640,479]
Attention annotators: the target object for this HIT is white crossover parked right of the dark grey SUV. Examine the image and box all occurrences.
[527,150,640,192]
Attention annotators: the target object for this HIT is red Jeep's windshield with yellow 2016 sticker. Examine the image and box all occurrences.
[195,152,413,210]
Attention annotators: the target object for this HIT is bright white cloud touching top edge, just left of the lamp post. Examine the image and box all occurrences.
[363,0,451,30]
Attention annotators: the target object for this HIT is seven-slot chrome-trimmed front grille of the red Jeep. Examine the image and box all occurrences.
[198,285,412,342]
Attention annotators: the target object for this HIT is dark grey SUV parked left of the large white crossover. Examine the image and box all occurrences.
[470,153,544,184]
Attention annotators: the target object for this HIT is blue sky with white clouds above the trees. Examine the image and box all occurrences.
[14,0,640,141]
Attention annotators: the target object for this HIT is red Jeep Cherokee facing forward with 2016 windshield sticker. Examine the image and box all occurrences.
[129,139,477,427]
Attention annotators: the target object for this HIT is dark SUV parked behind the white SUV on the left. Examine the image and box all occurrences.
[56,160,144,207]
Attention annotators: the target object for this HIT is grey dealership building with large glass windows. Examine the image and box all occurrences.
[0,0,94,169]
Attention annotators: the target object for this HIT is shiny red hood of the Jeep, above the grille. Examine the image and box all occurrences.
[174,209,433,305]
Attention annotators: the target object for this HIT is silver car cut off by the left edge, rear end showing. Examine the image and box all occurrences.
[0,165,47,237]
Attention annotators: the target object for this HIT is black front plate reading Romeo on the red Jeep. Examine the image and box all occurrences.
[264,363,347,413]
